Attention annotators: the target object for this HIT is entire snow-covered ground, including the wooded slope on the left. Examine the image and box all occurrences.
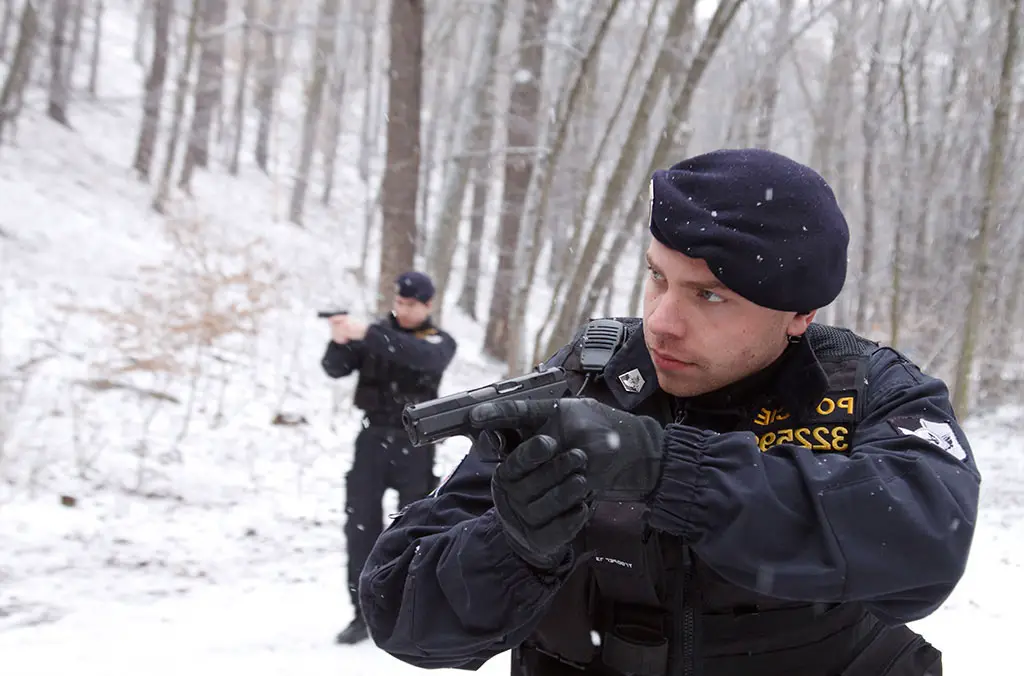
[0,5,1024,676]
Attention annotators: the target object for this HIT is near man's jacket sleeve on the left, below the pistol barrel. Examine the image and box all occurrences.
[359,451,572,670]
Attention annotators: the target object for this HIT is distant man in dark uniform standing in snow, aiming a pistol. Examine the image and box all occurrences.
[322,271,456,643]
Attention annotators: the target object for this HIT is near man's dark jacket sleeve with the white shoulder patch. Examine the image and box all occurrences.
[649,349,980,624]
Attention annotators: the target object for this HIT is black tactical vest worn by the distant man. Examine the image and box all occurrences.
[353,320,441,427]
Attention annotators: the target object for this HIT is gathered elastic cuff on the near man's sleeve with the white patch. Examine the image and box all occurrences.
[648,424,712,544]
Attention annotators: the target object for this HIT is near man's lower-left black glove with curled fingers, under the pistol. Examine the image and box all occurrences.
[490,436,590,571]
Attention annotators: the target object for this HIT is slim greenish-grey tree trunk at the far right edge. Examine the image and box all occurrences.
[952,0,1021,420]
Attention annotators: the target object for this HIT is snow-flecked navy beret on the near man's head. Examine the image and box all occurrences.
[650,149,850,312]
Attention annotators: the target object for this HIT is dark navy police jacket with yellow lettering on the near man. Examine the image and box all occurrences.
[360,320,980,676]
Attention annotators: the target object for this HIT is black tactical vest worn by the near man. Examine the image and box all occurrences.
[512,320,877,676]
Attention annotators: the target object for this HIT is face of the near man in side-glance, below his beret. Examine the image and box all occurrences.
[643,240,814,396]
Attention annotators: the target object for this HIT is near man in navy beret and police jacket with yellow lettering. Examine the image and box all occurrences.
[360,150,979,676]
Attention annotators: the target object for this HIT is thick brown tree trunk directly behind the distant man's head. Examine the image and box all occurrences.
[377,0,424,314]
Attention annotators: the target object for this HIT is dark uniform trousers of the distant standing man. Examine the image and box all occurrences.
[345,425,437,610]
